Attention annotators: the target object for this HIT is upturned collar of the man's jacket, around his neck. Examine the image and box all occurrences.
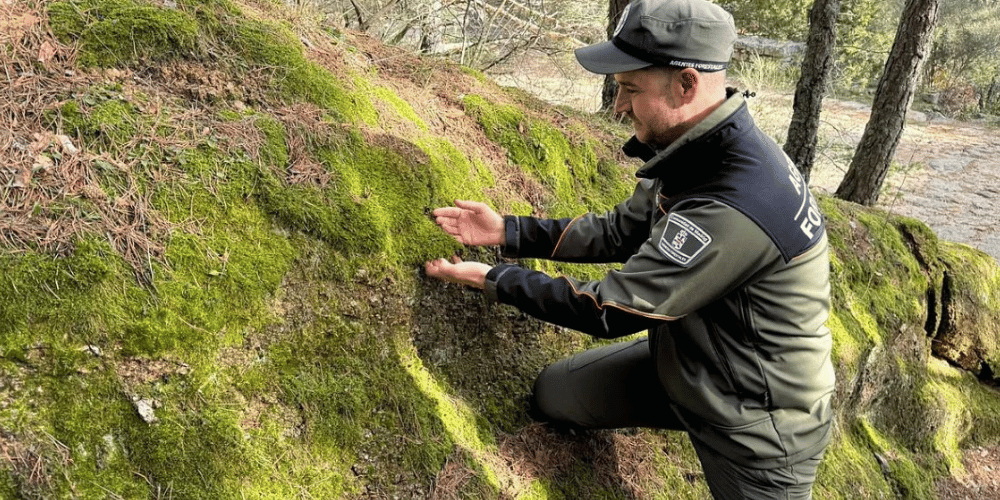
[622,92,749,179]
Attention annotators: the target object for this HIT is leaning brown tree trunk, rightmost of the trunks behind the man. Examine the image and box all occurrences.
[837,0,940,206]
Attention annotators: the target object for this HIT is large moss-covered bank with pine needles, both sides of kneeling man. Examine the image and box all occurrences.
[0,0,1000,499]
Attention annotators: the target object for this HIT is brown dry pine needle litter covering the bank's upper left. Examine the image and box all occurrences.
[0,0,329,285]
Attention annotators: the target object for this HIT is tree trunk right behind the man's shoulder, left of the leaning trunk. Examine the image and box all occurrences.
[784,0,840,182]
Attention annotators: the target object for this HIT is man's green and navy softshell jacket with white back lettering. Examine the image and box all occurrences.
[485,94,834,469]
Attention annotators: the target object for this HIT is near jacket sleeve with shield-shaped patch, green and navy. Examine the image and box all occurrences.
[485,200,782,338]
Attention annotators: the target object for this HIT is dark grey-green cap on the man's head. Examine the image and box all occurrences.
[576,0,736,75]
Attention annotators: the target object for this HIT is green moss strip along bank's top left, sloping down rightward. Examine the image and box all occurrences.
[49,0,378,125]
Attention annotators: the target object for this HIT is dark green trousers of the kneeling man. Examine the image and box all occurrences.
[532,337,822,500]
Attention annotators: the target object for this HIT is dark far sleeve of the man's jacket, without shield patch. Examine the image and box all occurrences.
[500,180,656,263]
